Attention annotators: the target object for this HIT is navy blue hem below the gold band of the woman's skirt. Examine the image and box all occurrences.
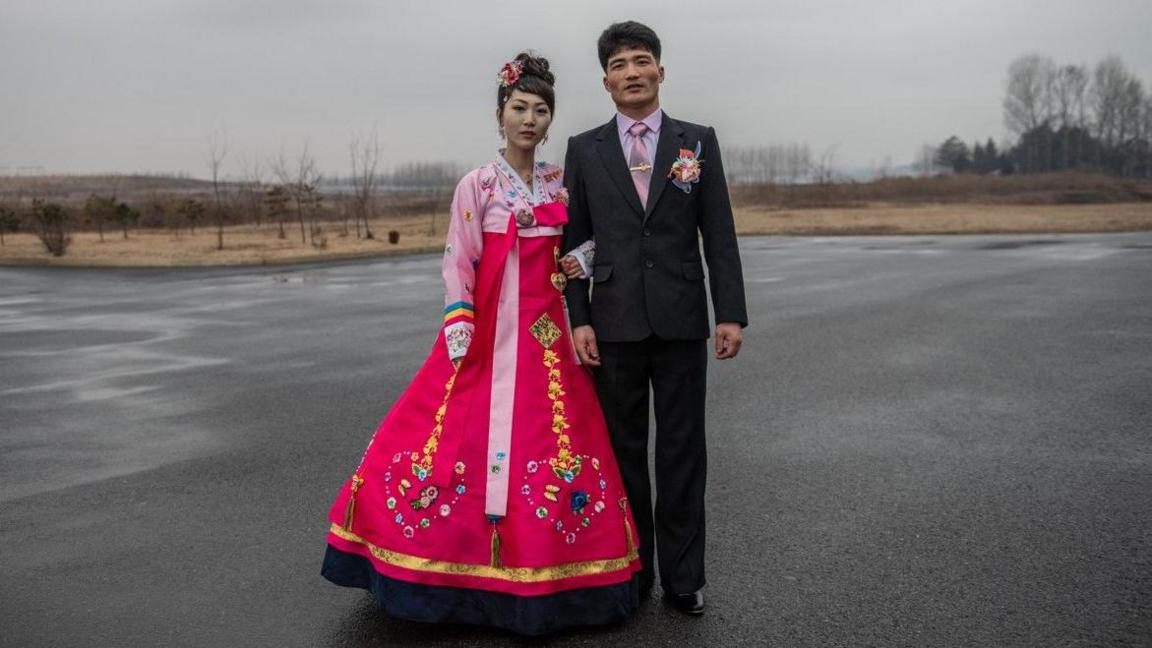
[320,545,639,635]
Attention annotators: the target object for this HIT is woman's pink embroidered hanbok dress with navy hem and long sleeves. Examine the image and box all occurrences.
[323,156,641,634]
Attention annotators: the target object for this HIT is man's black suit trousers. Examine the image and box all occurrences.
[596,337,707,594]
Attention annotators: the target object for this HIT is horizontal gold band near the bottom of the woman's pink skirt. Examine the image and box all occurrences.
[329,522,639,582]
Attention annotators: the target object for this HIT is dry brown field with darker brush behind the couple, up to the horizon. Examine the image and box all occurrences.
[0,172,1152,266]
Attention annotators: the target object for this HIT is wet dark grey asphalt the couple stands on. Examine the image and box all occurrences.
[0,234,1152,648]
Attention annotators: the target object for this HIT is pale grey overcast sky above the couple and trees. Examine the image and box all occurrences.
[0,0,1152,176]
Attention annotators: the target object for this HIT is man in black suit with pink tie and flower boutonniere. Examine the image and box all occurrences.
[563,22,748,615]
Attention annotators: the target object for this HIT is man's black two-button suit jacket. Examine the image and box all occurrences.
[562,114,748,341]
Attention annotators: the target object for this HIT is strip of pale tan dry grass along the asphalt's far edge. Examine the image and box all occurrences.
[0,203,1152,266]
